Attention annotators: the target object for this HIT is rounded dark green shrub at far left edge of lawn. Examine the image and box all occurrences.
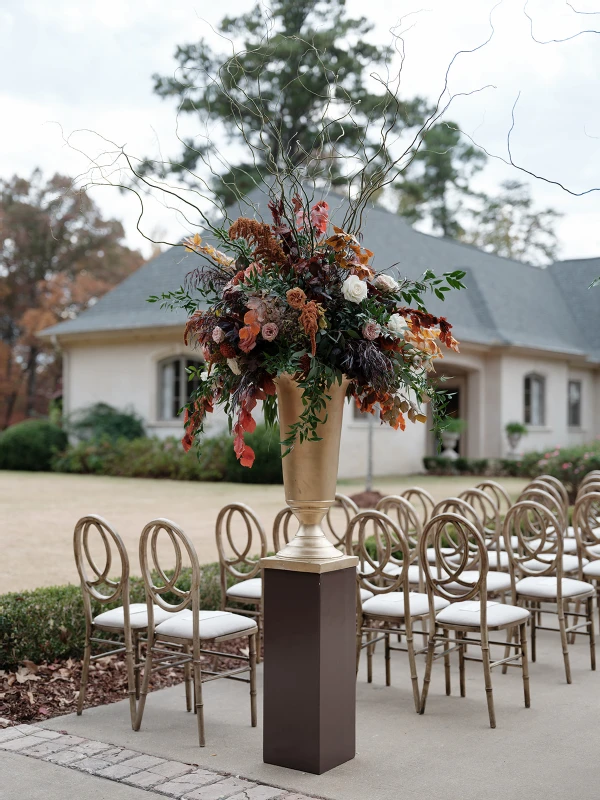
[0,419,67,471]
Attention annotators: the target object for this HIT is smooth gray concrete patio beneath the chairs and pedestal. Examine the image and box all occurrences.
[36,616,600,800]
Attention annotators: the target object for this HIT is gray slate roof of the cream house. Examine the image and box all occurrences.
[43,192,600,361]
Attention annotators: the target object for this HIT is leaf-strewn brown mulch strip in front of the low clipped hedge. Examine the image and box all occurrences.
[0,640,252,727]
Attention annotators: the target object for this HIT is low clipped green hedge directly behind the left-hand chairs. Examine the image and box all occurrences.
[0,563,221,669]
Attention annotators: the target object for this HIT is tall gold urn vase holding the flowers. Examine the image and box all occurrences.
[275,375,348,562]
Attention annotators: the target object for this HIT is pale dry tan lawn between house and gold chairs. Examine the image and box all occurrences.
[0,471,526,593]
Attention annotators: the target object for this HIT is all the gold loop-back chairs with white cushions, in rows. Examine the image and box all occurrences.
[74,474,600,746]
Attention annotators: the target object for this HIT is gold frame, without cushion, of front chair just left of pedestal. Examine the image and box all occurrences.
[135,519,257,747]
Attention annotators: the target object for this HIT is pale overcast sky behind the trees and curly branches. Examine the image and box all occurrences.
[0,0,600,258]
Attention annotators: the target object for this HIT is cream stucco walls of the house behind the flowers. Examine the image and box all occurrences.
[61,329,600,478]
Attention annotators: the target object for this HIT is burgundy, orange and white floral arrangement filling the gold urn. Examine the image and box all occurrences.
[150,194,465,467]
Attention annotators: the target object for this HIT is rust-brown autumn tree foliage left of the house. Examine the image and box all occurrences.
[0,170,142,427]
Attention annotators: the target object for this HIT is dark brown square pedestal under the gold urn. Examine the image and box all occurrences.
[263,559,356,775]
